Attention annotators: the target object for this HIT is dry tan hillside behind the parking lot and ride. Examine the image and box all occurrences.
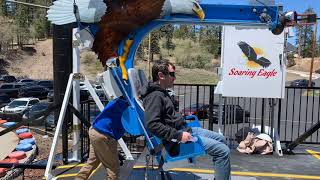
[0,39,320,84]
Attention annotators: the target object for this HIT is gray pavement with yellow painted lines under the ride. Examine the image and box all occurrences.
[54,145,320,180]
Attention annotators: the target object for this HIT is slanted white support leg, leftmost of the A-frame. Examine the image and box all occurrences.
[44,74,73,180]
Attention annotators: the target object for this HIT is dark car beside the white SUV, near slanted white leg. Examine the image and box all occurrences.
[22,102,52,126]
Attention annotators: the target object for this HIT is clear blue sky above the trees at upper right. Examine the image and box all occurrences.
[201,0,320,45]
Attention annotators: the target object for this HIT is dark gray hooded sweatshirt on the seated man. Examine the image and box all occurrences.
[142,82,192,149]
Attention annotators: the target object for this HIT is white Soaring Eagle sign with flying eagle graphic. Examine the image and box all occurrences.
[219,26,285,98]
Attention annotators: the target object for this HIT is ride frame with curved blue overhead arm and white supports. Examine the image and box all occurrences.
[45,4,284,179]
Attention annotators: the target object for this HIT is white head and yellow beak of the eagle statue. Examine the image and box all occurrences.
[162,0,205,20]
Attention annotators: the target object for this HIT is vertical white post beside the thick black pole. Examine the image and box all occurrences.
[69,28,81,162]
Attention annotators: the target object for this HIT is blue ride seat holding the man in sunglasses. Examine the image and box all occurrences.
[128,68,205,166]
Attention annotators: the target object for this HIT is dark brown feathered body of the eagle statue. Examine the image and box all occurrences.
[93,0,164,66]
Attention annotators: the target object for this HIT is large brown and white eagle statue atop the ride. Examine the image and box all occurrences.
[47,0,205,66]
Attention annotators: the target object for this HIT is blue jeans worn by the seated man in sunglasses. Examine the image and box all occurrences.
[192,127,231,180]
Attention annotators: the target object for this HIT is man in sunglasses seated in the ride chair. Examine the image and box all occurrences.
[142,60,230,180]
